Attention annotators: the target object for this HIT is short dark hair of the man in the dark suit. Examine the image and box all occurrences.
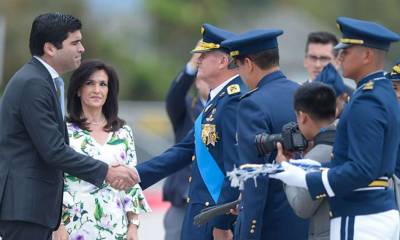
[29,12,82,56]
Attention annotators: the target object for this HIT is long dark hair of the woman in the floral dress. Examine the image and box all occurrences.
[67,59,126,132]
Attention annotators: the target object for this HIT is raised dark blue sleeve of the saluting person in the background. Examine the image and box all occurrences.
[165,67,196,131]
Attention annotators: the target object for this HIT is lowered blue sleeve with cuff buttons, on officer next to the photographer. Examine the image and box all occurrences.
[237,98,270,239]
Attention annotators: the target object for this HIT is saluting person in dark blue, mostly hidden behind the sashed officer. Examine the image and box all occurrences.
[163,44,210,240]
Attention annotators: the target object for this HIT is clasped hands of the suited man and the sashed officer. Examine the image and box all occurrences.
[105,164,140,191]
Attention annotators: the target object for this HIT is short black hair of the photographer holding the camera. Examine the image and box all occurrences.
[294,82,336,121]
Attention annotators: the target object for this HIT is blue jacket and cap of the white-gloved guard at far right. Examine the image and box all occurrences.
[306,17,400,239]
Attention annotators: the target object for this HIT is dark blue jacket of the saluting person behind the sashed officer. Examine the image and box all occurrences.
[163,70,203,207]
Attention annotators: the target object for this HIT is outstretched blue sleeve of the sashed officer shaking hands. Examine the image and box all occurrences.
[136,129,194,190]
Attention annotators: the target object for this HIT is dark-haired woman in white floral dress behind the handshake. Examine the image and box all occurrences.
[53,60,150,240]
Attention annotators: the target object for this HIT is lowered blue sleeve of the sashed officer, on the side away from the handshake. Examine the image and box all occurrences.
[213,96,239,229]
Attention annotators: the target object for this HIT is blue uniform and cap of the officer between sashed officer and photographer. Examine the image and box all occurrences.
[222,30,308,240]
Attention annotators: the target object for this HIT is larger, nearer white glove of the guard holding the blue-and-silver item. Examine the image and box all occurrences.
[268,162,308,189]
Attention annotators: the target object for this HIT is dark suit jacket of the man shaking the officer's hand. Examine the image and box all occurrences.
[0,58,107,228]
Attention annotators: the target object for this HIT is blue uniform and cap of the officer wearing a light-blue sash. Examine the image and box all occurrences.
[137,24,246,240]
